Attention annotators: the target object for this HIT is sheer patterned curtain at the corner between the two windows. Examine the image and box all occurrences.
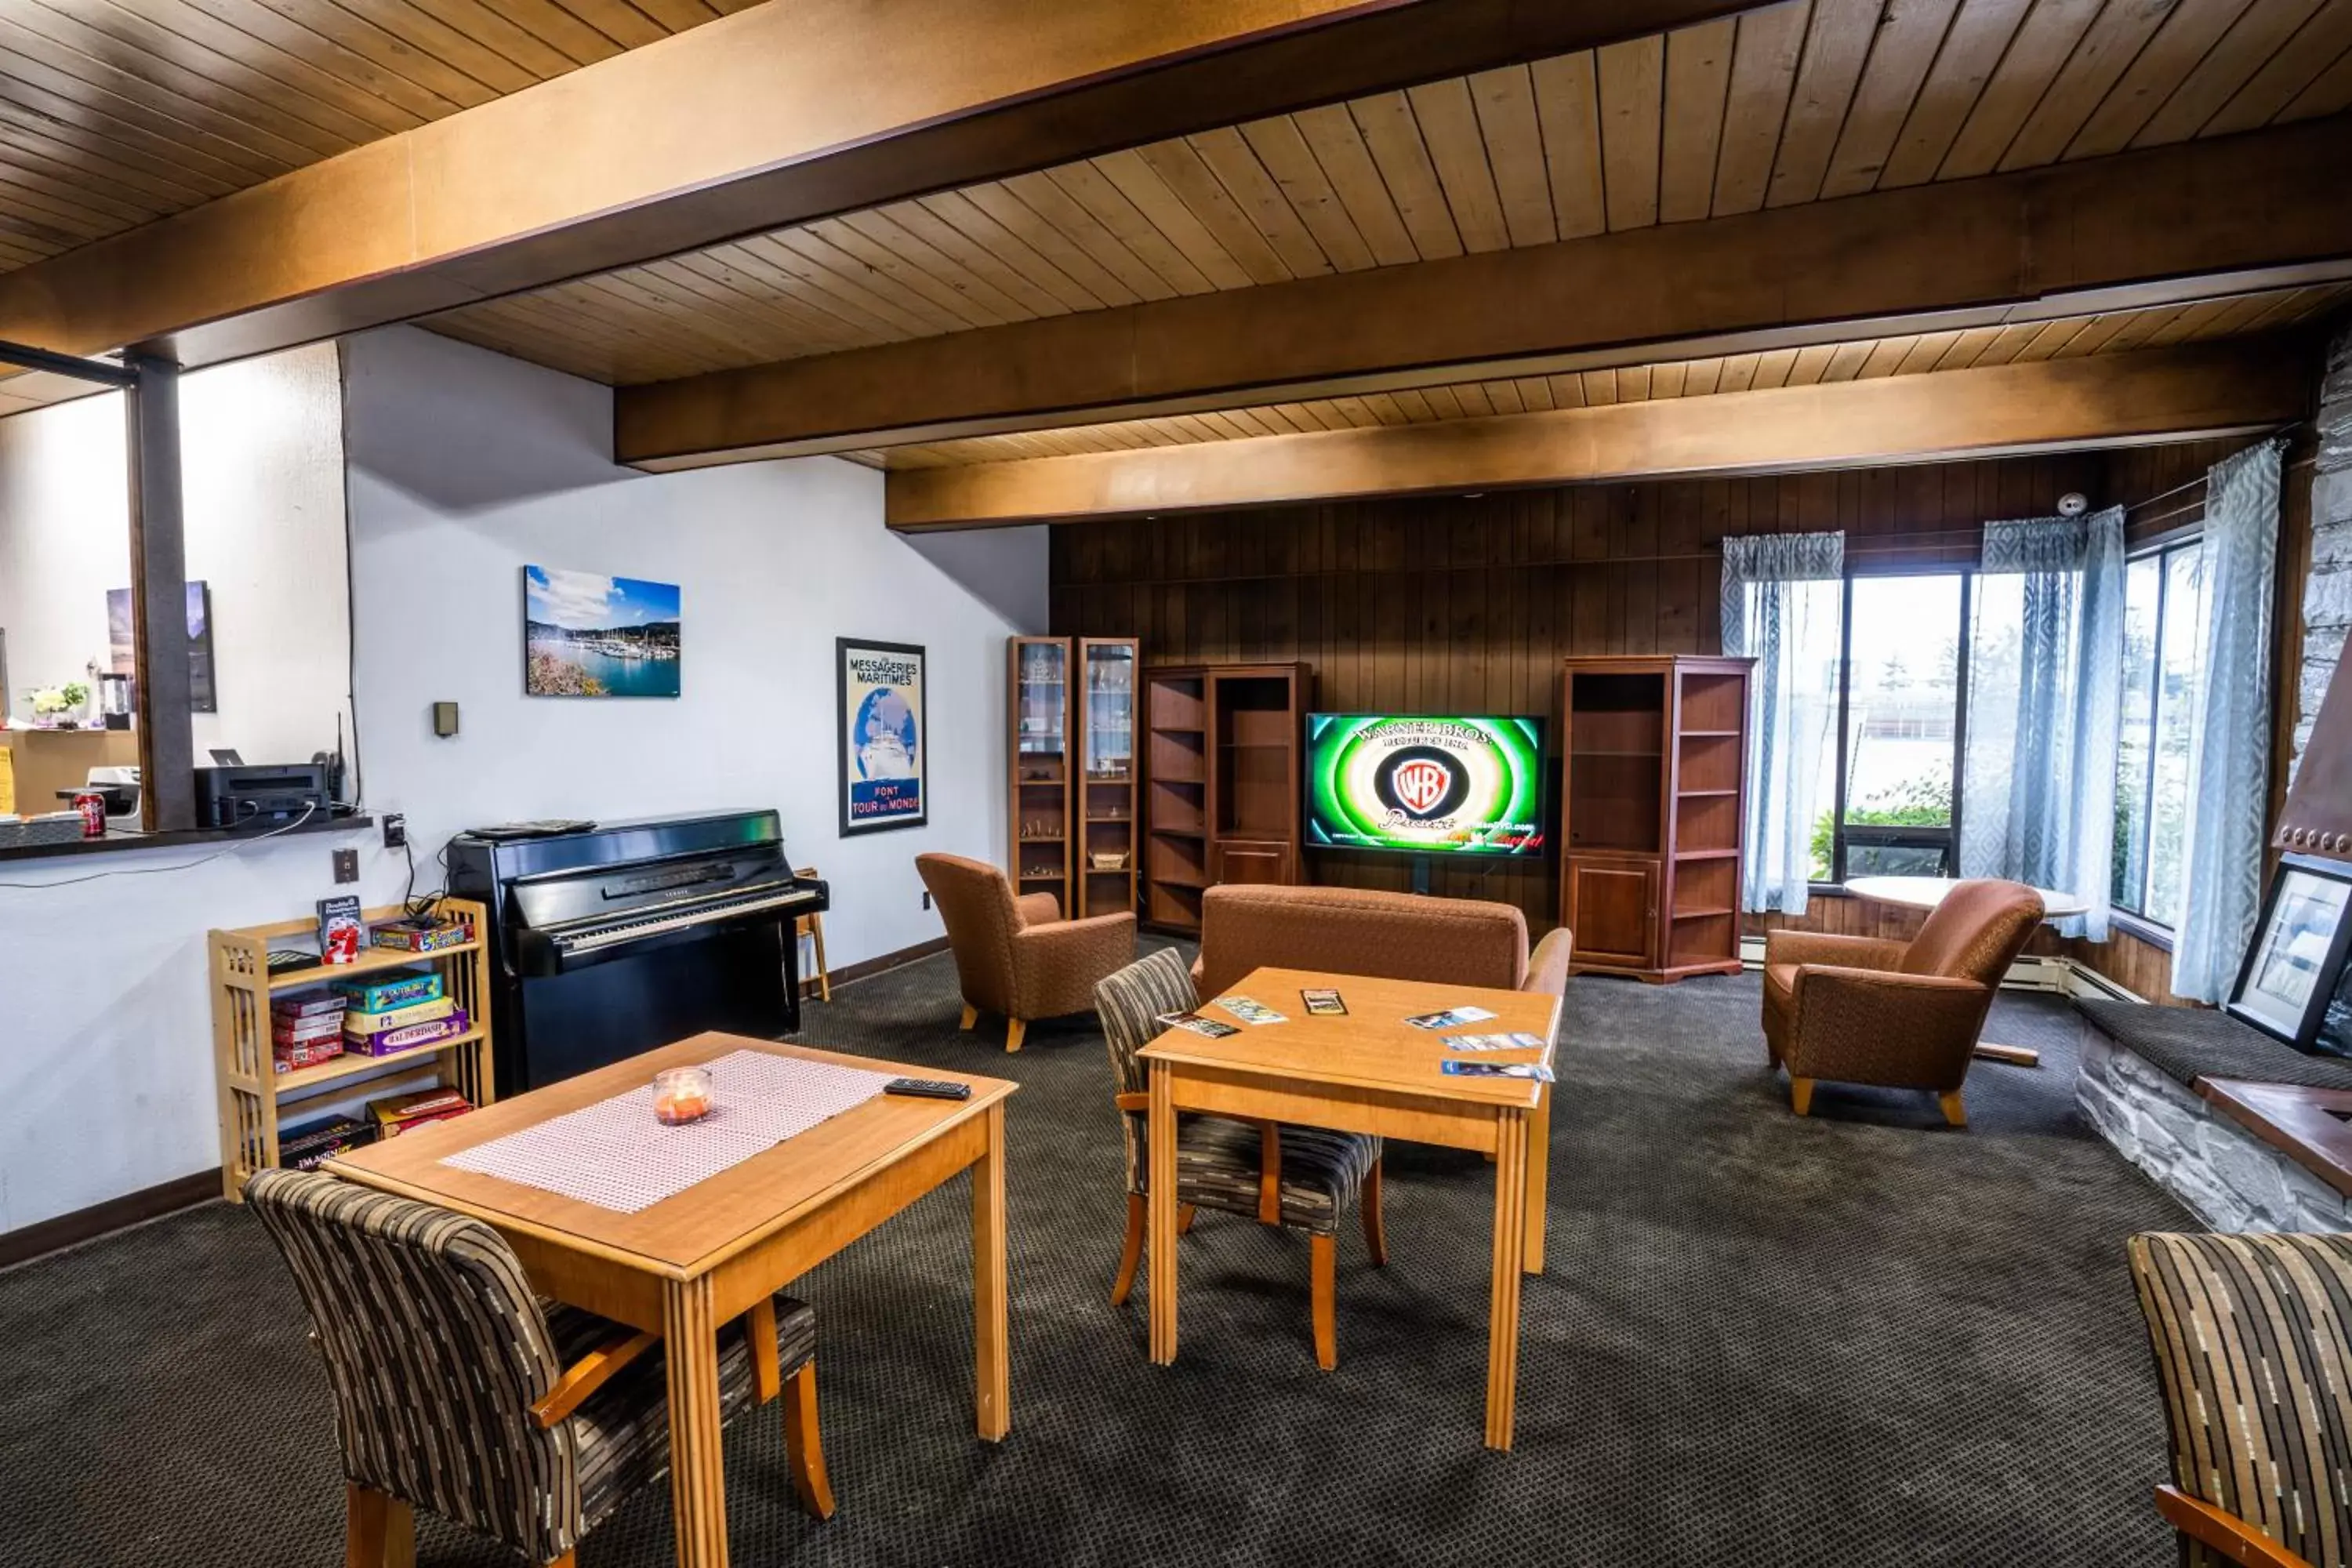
[1959,508,2124,942]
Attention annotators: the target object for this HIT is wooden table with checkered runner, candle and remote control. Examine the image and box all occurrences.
[325,1034,1018,1568]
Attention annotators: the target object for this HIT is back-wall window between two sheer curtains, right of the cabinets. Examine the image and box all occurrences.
[1813,572,1971,881]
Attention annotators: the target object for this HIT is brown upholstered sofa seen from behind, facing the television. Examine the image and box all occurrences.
[1192,884,1569,996]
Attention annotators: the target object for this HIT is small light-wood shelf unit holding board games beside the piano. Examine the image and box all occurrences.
[205,898,496,1201]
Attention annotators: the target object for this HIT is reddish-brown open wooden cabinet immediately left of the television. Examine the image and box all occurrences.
[1143,663,1315,931]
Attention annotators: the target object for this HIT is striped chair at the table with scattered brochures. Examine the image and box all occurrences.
[1094,947,1388,1373]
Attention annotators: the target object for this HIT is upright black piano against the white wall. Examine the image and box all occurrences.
[449,811,828,1095]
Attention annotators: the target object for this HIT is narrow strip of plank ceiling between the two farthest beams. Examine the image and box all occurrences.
[842,285,2352,470]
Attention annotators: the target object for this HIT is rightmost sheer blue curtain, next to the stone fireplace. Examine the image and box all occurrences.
[2173,440,2284,1001]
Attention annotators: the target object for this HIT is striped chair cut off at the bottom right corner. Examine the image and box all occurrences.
[2131,1234,2352,1568]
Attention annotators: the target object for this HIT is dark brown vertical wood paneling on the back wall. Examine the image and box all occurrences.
[1051,440,2310,999]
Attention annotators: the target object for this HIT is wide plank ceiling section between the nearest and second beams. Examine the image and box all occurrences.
[423,0,2352,386]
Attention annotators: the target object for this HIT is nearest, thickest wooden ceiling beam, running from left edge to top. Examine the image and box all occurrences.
[0,0,1752,365]
